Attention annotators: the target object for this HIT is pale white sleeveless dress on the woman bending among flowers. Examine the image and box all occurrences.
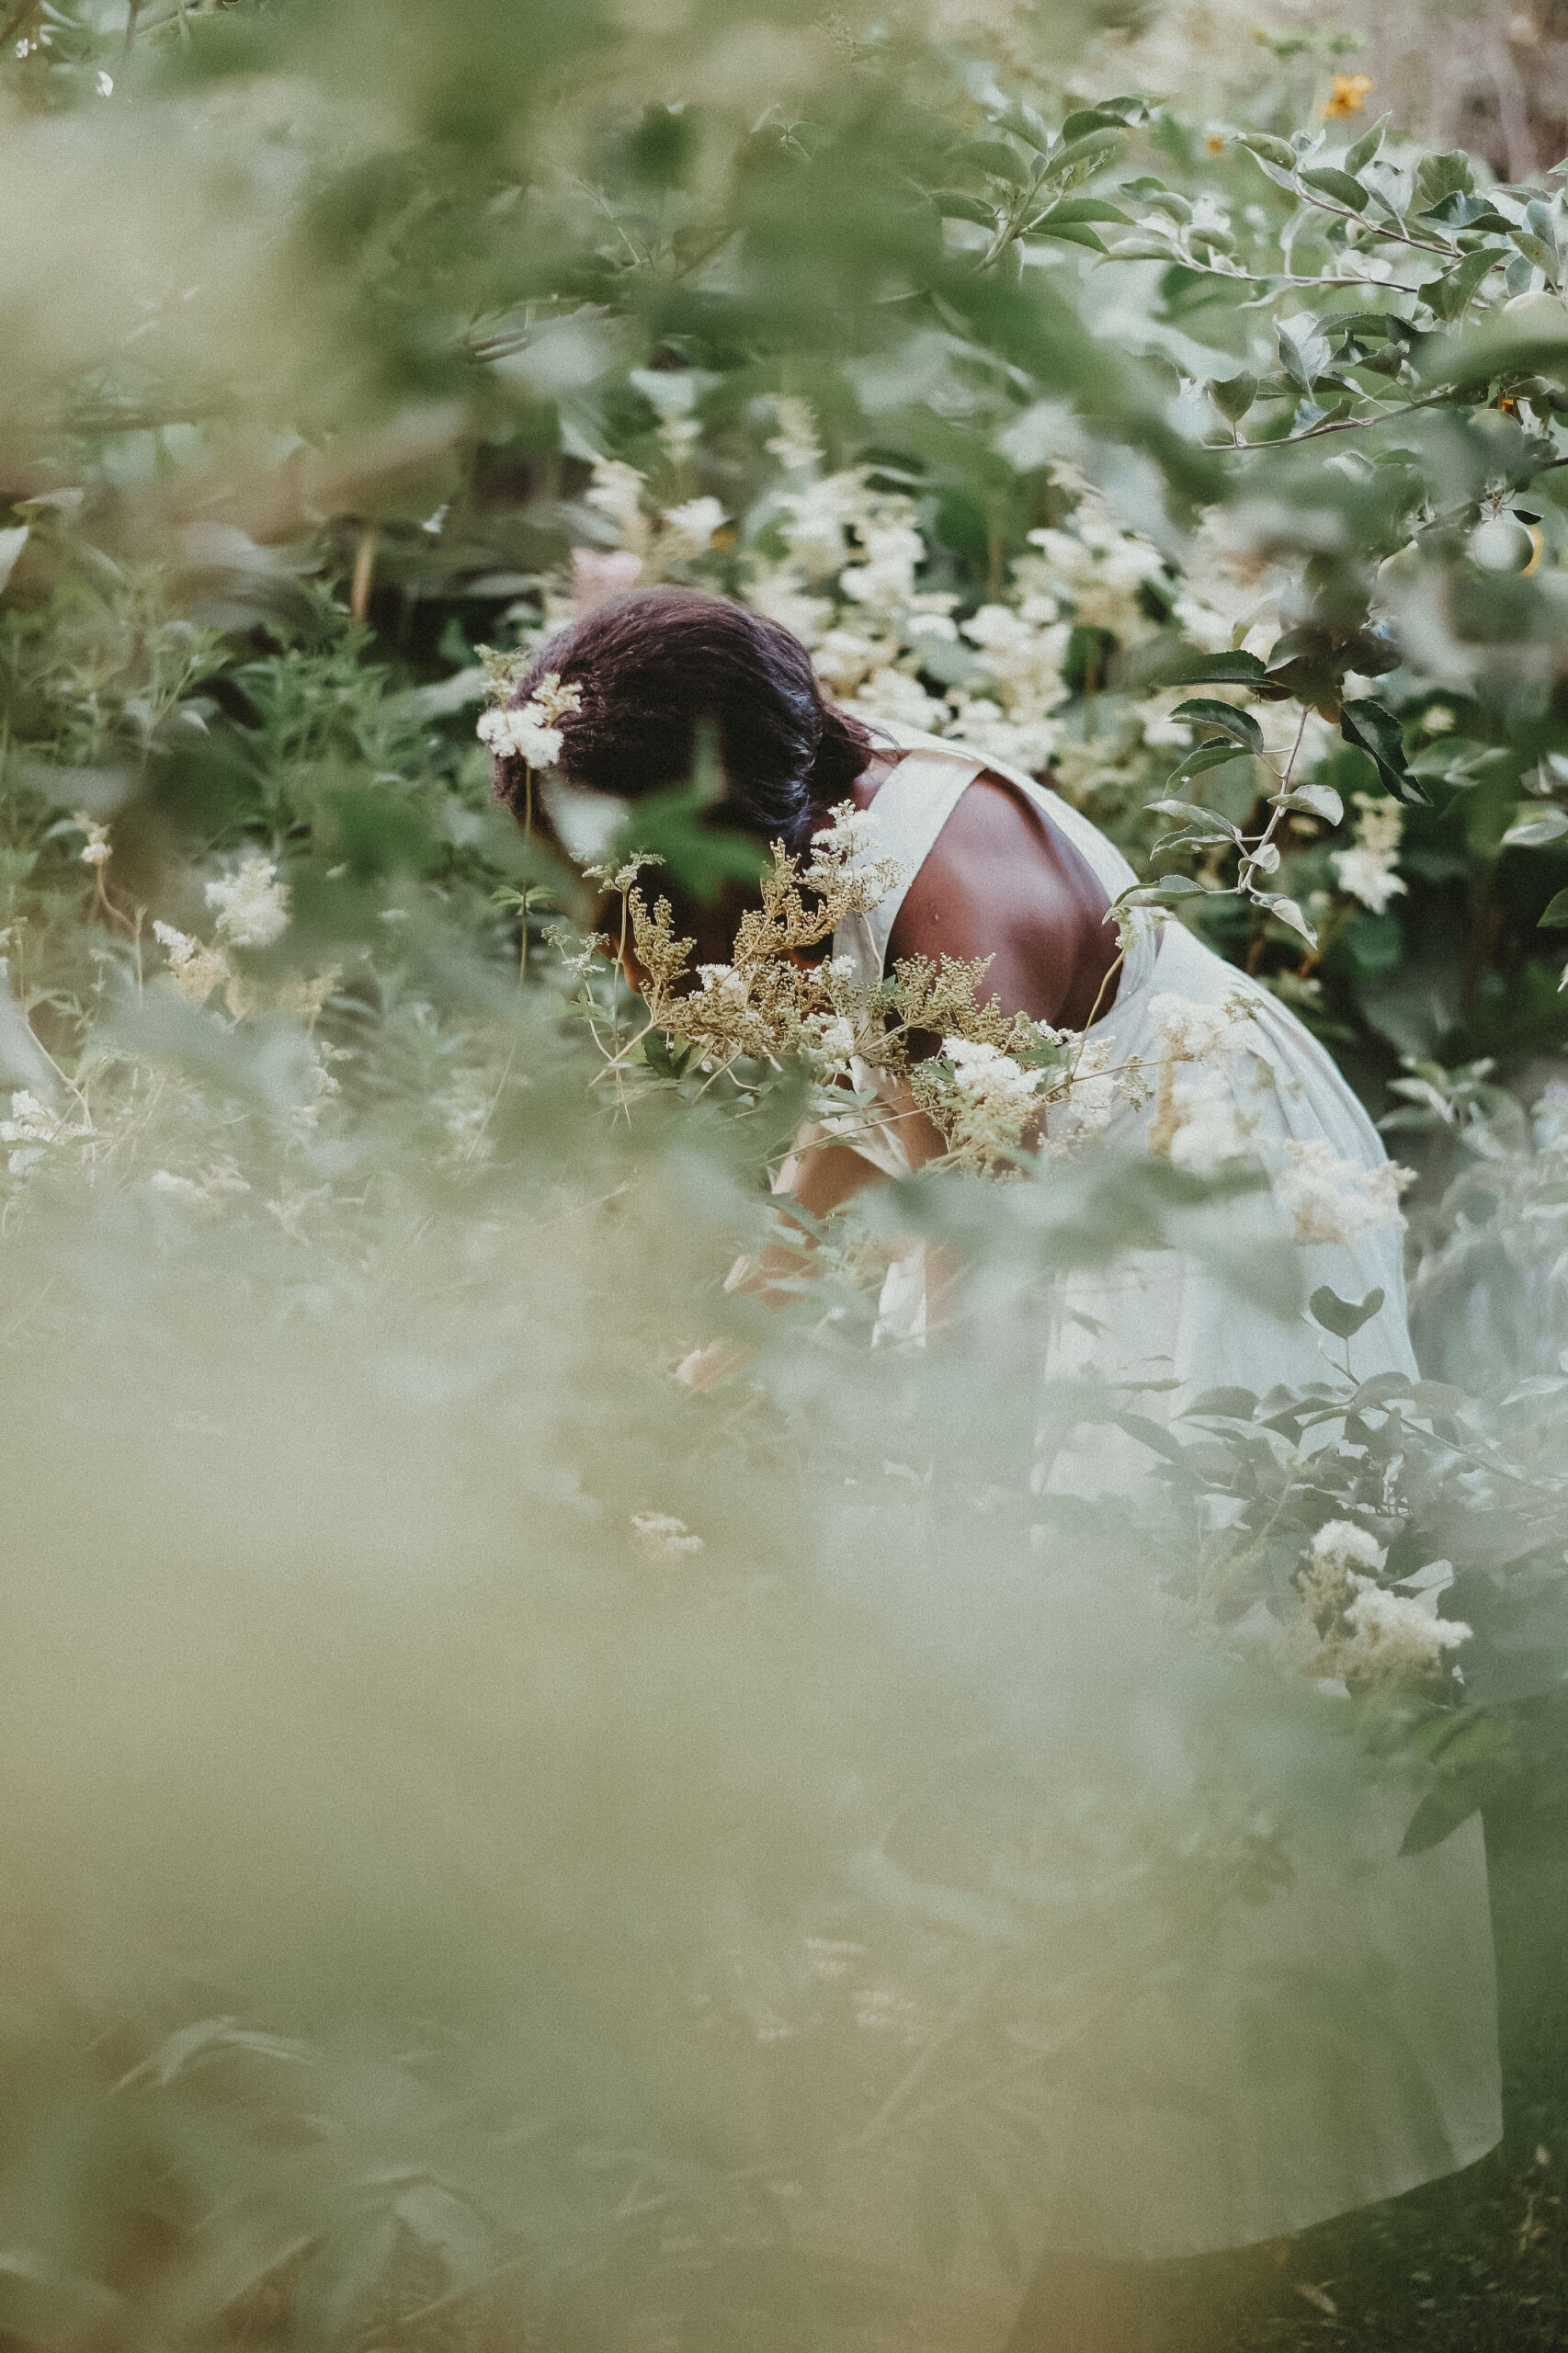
[795,727,1502,2305]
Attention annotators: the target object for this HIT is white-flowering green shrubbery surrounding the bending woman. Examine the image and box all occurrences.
[0,0,1568,2346]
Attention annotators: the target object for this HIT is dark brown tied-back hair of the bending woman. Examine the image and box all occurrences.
[494,588,876,849]
